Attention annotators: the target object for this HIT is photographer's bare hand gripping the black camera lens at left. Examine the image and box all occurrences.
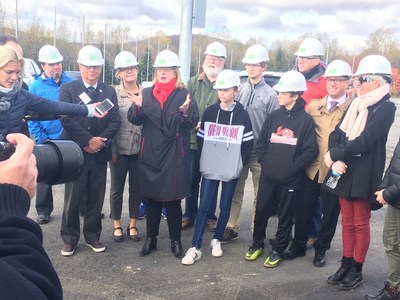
[0,133,38,199]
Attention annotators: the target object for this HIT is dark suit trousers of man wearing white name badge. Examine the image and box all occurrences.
[61,153,107,245]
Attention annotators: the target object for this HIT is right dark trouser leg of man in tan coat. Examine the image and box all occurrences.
[314,189,340,252]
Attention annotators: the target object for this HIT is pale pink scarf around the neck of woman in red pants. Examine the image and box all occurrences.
[340,84,390,141]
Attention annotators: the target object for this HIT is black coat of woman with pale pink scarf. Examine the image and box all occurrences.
[323,94,396,204]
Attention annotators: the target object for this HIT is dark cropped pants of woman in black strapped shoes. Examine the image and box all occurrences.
[110,154,141,220]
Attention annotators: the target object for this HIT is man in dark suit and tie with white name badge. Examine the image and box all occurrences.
[59,45,121,256]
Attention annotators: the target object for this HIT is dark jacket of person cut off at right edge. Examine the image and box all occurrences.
[378,140,400,209]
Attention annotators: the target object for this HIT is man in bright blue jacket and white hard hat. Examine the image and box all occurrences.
[28,45,72,224]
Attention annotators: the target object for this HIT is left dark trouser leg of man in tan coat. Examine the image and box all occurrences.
[293,174,321,250]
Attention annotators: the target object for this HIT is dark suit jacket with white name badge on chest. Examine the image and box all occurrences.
[59,79,121,162]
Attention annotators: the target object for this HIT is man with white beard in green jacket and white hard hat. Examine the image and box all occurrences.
[182,42,226,231]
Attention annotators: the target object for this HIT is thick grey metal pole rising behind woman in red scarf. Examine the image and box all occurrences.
[179,0,193,83]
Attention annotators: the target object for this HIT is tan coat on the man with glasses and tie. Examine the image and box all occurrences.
[306,96,351,183]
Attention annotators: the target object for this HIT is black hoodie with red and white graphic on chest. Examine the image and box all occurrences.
[256,98,318,189]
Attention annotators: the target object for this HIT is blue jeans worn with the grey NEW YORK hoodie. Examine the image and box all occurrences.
[192,177,238,249]
